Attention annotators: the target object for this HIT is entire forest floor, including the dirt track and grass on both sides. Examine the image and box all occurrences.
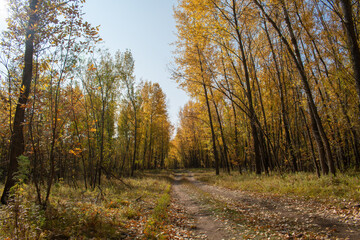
[0,169,360,240]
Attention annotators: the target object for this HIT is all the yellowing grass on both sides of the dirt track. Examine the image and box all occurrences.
[0,169,360,239]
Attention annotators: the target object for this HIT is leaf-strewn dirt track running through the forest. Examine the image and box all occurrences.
[172,172,360,239]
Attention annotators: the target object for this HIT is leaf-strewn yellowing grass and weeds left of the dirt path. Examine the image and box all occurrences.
[0,173,170,239]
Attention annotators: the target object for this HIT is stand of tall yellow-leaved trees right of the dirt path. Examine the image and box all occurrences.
[173,0,360,175]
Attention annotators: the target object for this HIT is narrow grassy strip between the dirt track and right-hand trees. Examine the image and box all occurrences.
[192,170,360,203]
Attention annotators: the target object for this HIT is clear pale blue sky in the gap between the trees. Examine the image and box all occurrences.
[0,0,189,125]
